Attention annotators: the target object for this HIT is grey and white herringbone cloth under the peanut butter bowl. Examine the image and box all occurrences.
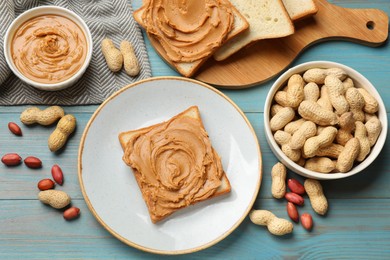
[0,0,151,105]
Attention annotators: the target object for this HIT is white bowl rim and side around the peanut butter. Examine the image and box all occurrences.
[3,5,93,91]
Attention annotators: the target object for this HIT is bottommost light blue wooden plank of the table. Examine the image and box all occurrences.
[0,199,390,259]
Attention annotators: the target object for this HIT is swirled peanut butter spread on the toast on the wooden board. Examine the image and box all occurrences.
[142,0,234,62]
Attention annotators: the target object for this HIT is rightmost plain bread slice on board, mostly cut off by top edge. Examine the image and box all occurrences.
[282,0,318,21]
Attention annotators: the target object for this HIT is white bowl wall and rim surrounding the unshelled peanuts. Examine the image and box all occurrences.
[263,60,388,180]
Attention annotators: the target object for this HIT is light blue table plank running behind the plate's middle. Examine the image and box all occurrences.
[0,113,390,199]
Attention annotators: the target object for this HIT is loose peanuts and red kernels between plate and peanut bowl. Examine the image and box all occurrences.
[249,162,328,236]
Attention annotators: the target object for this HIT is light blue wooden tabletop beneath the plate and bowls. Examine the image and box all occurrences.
[0,0,390,259]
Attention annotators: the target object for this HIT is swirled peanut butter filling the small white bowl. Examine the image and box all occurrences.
[11,15,87,83]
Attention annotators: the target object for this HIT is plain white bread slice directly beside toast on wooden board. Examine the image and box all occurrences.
[214,0,294,61]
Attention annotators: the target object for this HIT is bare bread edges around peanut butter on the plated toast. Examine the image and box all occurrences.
[118,106,231,223]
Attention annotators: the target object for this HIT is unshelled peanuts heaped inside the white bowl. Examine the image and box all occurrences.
[270,68,382,173]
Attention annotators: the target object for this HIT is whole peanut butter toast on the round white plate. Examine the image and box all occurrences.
[119,106,231,223]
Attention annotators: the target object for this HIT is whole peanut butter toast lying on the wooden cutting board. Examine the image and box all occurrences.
[133,0,249,77]
